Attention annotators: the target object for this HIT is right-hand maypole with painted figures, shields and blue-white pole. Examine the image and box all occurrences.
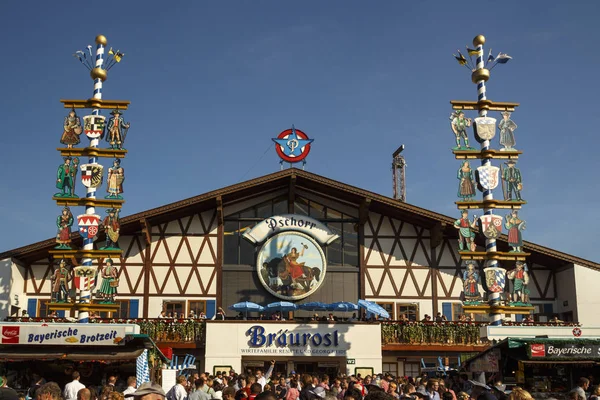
[450,35,531,325]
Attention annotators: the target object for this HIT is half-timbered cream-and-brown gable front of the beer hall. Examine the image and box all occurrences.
[0,169,598,320]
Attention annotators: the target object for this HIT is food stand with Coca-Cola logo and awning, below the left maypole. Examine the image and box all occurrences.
[0,322,165,394]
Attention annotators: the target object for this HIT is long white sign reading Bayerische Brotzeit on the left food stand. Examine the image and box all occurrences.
[0,323,140,346]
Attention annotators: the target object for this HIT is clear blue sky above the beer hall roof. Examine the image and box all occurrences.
[0,0,600,261]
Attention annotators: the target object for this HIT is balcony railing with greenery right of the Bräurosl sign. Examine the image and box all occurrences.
[381,321,487,345]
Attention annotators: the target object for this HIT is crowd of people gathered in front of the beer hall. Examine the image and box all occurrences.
[0,361,600,400]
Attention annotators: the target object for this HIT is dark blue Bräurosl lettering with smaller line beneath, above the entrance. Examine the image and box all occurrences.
[241,325,346,356]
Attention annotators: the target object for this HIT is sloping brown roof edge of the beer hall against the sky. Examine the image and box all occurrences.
[0,168,600,270]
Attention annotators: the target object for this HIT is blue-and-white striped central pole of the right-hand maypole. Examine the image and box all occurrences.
[472,35,502,326]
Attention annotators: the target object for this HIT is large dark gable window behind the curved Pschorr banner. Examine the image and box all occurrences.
[223,197,359,266]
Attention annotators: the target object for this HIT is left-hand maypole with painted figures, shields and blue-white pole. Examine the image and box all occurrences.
[49,35,129,323]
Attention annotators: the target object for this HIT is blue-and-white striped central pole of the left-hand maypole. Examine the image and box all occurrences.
[77,35,107,323]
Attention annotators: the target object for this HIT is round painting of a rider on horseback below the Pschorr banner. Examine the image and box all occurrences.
[257,232,327,300]
